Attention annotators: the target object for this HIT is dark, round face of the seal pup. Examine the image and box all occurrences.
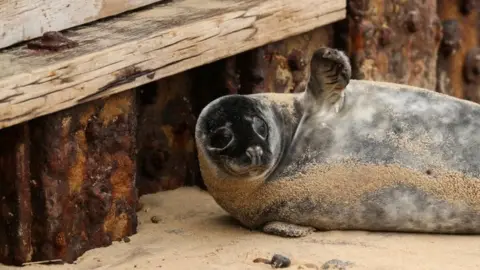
[196,95,281,177]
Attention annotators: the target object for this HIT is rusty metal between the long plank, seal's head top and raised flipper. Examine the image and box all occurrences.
[227,26,333,94]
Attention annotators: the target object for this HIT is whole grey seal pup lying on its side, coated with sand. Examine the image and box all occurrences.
[195,47,480,237]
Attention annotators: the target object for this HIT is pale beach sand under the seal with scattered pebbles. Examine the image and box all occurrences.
[0,187,480,270]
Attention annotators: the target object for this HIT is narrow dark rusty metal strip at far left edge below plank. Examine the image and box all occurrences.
[0,124,33,264]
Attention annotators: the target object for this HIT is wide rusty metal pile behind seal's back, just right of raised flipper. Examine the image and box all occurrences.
[344,0,442,90]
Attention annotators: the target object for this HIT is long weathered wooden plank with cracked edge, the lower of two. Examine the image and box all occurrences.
[0,0,346,128]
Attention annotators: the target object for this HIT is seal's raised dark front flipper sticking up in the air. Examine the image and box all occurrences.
[306,47,352,111]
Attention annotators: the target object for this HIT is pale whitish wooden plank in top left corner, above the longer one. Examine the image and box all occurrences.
[0,0,164,48]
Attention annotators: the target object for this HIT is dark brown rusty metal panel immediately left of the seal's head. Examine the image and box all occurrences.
[137,73,198,195]
